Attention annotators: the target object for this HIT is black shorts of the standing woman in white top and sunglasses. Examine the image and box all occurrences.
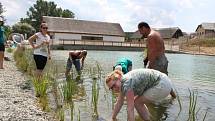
[34,55,47,70]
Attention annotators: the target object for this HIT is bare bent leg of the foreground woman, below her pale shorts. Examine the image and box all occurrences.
[134,96,150,121]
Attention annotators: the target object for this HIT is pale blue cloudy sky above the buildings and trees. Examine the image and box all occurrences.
[0,0,215,33]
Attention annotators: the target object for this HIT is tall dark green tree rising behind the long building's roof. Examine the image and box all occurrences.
[20,0,75,31]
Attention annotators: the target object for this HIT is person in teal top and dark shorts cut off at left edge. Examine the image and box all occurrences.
[0,16,6,69]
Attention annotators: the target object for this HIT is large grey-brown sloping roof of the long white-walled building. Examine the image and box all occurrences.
[43,16,125,36]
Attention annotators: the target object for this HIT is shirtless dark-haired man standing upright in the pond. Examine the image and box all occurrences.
[138,22,168,74]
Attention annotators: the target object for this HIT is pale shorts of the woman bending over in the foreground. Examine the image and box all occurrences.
[143,74,172,102]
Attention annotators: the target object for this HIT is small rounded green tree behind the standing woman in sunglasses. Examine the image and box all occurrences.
[12,23,35,37]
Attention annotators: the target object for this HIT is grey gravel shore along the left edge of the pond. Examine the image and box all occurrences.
[0,52,55,121]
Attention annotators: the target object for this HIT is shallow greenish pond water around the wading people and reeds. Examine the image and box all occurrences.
[52,51,215,121]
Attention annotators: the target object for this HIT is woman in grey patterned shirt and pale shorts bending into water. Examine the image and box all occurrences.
[106,69,176,121]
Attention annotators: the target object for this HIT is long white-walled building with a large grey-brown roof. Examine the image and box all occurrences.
[43,16,125,44]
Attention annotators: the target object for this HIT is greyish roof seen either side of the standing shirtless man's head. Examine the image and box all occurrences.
[131,27,183,39]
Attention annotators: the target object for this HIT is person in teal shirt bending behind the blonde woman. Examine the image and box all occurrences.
[113,58,132,74]
